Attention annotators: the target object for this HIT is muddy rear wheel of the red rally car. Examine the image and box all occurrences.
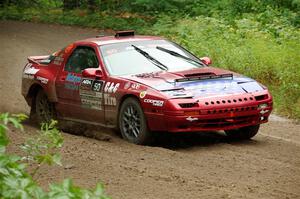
[34,90,56,124]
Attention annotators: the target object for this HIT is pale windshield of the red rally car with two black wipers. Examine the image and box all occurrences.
[100,40,202,76]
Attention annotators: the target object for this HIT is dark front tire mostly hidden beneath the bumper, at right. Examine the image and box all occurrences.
[225,125,259,140]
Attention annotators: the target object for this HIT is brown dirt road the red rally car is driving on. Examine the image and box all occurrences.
[0,21,300,199]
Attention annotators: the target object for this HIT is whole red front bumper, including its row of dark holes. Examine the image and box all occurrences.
[146,91,272,132]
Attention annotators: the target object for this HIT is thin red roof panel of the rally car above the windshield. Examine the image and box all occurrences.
[75,35,162,46]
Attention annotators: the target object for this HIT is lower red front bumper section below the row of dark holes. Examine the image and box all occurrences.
[146,106,272,132]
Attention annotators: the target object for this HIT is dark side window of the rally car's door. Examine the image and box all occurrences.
[64,46,99,73]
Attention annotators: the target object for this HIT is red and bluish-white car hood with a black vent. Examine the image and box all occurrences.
[120,67,264,98]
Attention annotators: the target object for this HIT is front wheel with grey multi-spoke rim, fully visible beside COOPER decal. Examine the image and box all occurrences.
[118,97,153,145]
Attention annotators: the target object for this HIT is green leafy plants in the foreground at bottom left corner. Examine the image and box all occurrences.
[0,113,108,199]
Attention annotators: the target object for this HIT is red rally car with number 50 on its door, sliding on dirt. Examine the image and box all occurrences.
[22,31,272,144]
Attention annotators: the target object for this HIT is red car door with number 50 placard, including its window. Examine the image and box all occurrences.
[56,45,104,123]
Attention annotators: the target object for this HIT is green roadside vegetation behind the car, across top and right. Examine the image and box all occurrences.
[0,0,300,119]
